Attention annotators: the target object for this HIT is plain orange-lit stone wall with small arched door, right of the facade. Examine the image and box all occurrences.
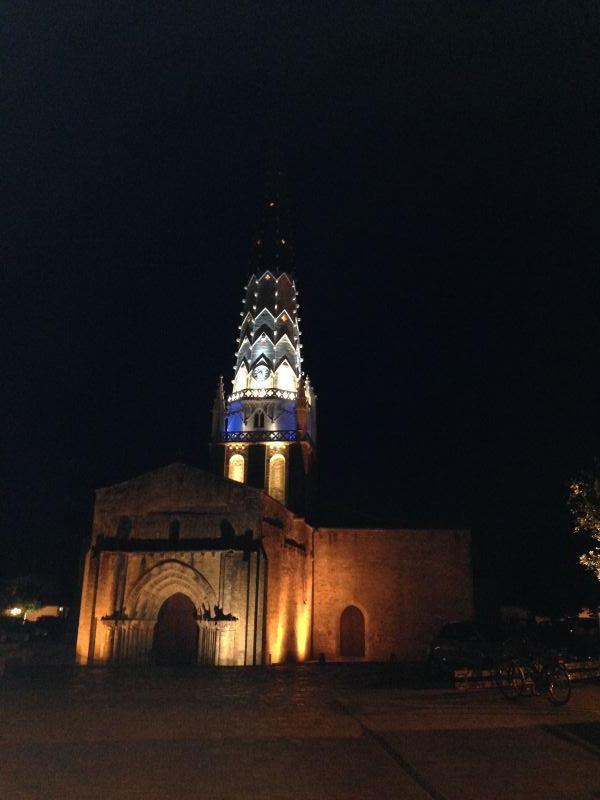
[313,528,473,661]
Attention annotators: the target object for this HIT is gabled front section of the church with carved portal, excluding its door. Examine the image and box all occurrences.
[77,464,310,665]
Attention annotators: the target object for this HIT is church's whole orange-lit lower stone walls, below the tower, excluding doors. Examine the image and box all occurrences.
[77,463,472,666]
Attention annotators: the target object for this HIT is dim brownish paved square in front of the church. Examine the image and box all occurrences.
[0,664,600,800]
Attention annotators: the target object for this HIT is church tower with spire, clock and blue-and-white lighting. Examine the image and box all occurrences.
[213,185,316,514]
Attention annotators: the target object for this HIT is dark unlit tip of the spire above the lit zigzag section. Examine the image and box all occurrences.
[251,153,294,275]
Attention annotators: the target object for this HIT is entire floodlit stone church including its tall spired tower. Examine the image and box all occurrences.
[77,192,473,666]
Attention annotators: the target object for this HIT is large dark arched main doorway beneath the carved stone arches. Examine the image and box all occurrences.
[154,592,198,664]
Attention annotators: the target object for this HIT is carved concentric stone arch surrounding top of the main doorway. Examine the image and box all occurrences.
[125,559,217,619]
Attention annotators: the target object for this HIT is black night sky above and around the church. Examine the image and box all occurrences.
[0,0,600,607]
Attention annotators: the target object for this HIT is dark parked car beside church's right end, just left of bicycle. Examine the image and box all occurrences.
[429,620,511,670]
